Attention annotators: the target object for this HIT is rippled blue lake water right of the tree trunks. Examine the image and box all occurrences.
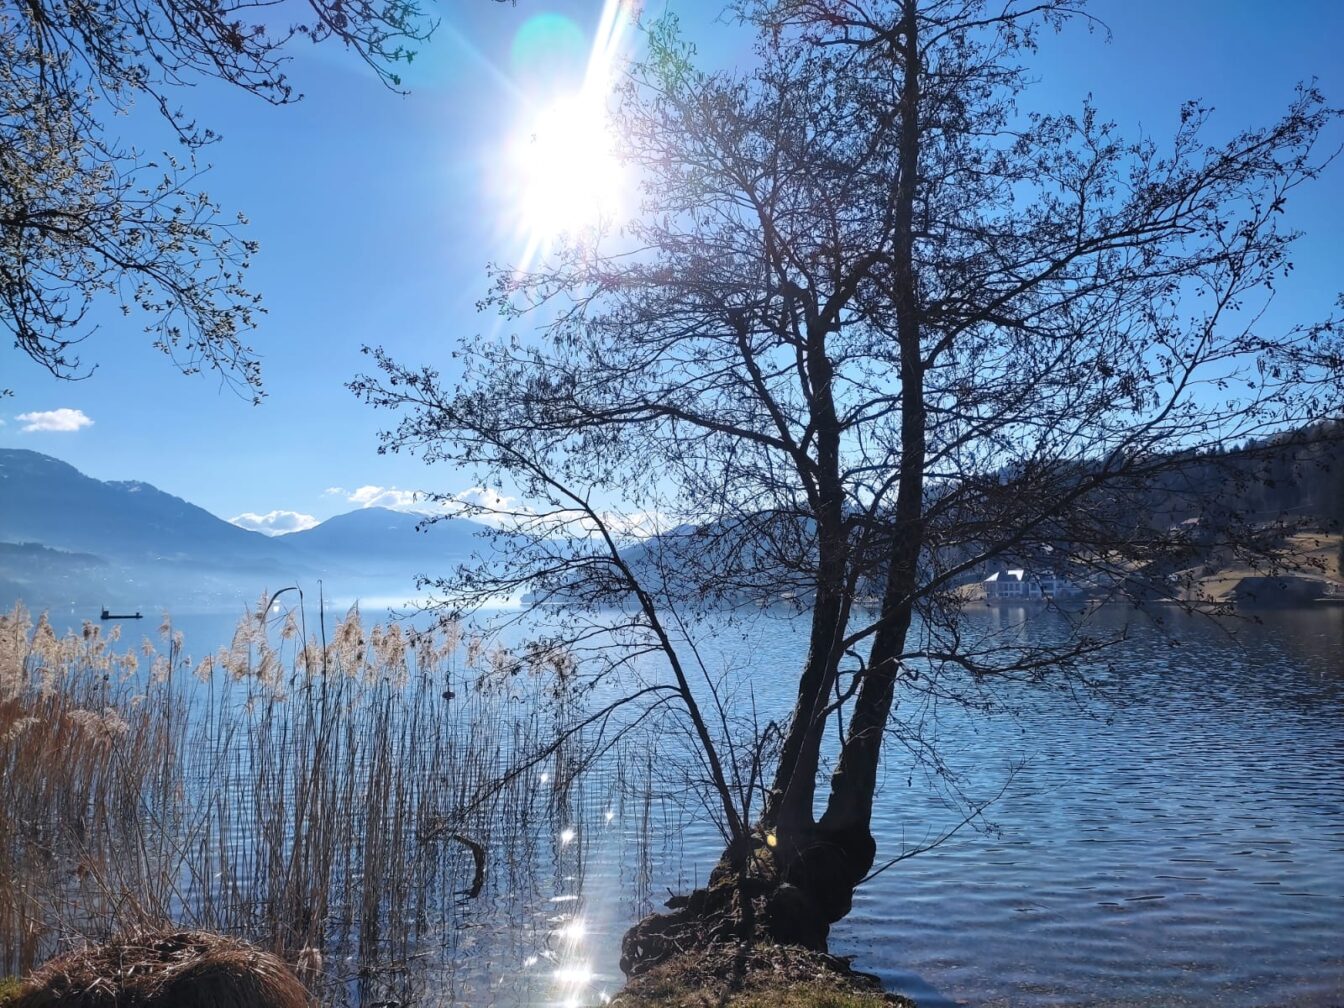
[835,610,1344,1008]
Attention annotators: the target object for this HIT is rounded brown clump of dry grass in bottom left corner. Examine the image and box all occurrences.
[9,931,309,1008]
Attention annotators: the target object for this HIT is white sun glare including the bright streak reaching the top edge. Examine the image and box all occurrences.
[509,0,630,266]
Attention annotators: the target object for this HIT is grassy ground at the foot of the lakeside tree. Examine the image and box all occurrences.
[610,943,915,1008]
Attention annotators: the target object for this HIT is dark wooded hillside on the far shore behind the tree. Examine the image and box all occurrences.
[532,421,1344,606]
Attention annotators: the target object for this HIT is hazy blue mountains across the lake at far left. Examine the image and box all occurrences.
[0,449,491,616]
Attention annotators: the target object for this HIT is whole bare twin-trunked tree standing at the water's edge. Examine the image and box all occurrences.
[353,0,1344,969]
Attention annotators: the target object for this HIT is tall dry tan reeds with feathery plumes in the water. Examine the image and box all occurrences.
[0,602,615,1003]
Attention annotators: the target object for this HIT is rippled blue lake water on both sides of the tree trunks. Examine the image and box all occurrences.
[26,609,1344,1008]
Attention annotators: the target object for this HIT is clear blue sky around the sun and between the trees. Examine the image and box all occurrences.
[0,0,1344,537]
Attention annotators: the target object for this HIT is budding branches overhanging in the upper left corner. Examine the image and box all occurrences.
[0,0,429,396]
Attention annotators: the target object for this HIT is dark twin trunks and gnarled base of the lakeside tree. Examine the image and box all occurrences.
[621,0,925,974]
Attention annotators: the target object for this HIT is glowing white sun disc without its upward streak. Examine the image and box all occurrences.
[513,94,621,245]
